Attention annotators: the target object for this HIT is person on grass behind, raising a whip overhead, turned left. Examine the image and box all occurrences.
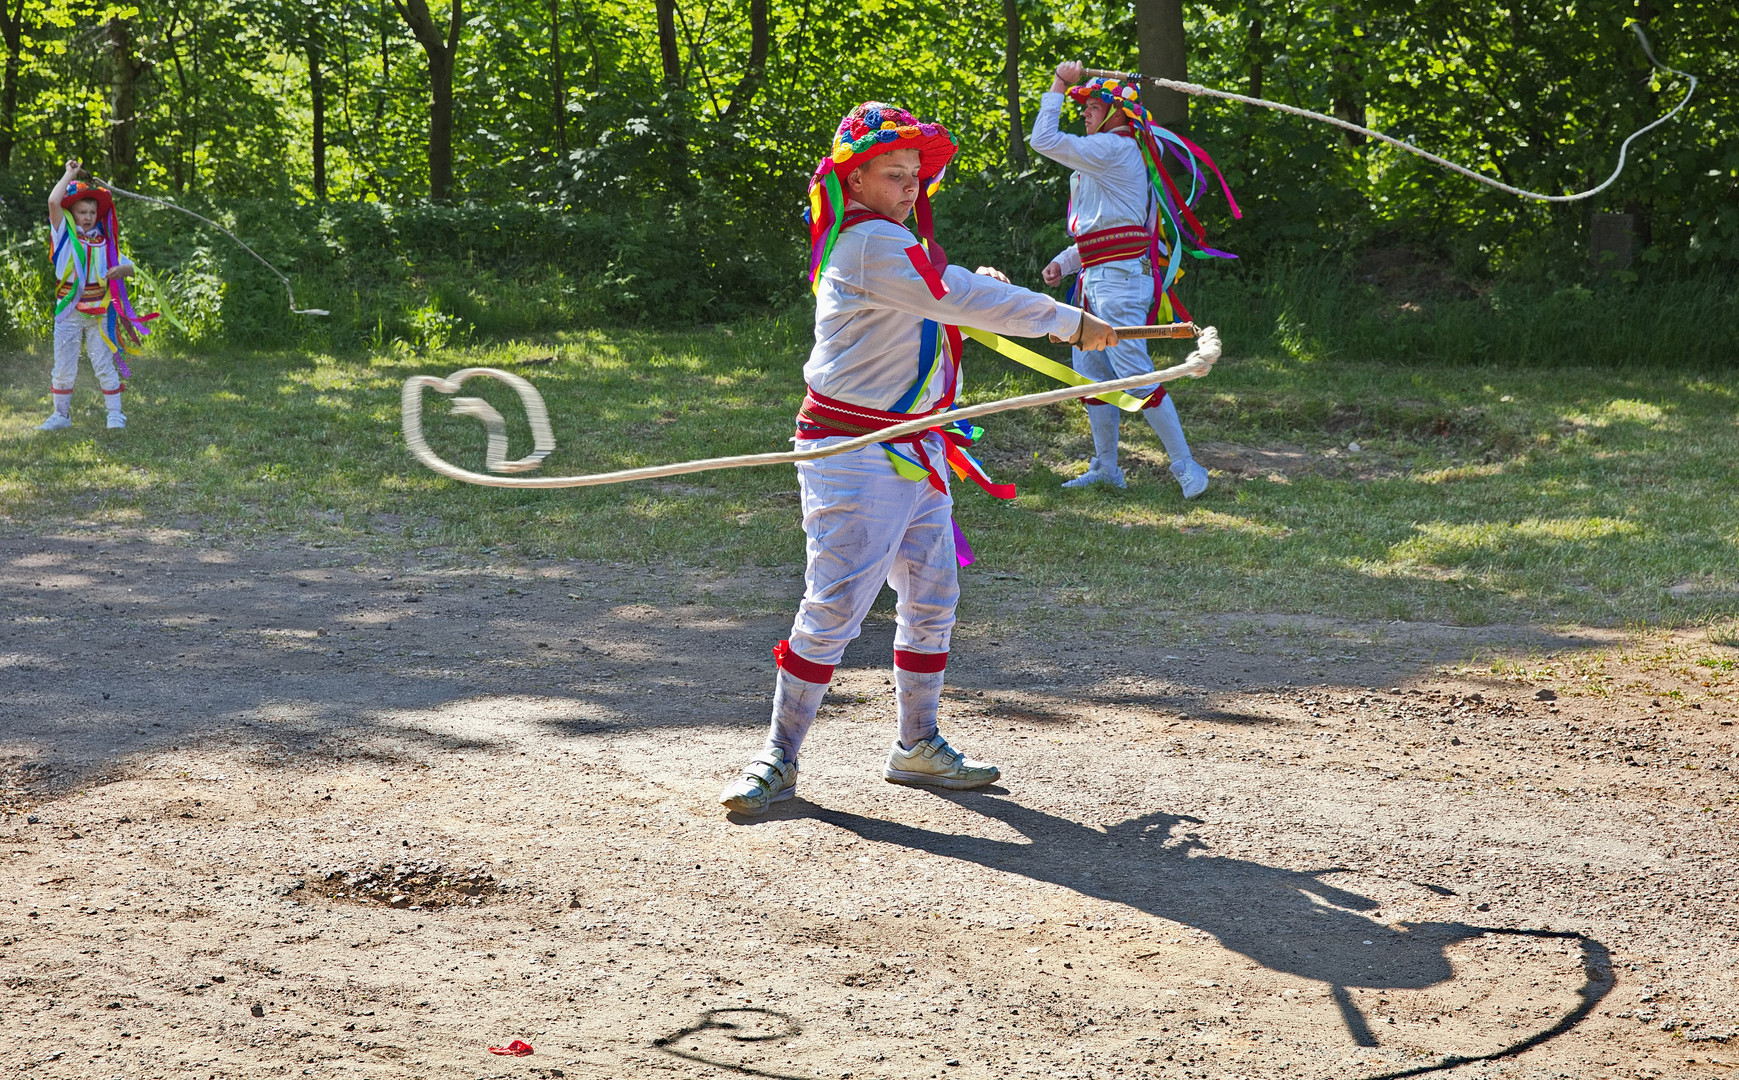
[1031,61,1236,499]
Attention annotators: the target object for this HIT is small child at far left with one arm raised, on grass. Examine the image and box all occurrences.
[38,162,157,431]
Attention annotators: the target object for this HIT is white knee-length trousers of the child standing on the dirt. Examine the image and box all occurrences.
[791,435,960,664]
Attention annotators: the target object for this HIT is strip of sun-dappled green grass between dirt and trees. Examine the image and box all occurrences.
[0,311,1739,624]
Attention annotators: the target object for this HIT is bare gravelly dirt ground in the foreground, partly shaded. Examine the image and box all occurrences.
[0,529,1739,1080]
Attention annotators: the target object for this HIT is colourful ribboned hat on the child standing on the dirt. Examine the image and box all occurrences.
[809,101,956,287]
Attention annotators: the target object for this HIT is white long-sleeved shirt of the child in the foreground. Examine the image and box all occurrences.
[803,203,1082,412]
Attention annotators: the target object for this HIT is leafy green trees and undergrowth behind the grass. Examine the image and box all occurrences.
[0,0,1739,367]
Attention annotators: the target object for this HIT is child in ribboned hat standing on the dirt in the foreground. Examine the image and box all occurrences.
[720,101,1116,814]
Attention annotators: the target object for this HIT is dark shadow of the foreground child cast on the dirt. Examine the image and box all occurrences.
[809,793,1612,1080]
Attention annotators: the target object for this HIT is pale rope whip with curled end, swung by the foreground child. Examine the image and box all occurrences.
[400,327,1219,489]
